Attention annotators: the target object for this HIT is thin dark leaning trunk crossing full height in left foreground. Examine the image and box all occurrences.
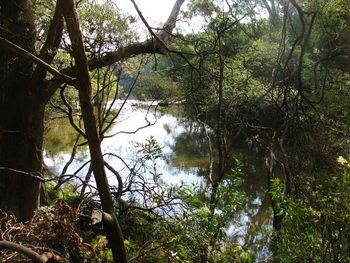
[60,0,127,263]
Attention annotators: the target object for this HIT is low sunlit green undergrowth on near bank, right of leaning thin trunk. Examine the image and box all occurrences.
[103,158,246,262]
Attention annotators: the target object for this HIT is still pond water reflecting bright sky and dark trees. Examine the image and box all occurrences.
[45,101,272,262]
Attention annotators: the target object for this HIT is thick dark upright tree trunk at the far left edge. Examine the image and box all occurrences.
[0,0,44,220]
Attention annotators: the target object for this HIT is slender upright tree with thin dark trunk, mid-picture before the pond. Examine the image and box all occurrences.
[168,1,261,262]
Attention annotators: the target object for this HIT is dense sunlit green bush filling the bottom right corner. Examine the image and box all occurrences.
[271,165,350,262]
